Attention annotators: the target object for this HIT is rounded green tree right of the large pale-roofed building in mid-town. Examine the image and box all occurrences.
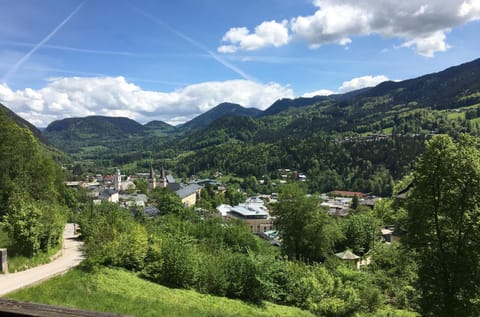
[274,184,342,262]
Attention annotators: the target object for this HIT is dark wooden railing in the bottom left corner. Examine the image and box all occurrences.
[0,298,129,317]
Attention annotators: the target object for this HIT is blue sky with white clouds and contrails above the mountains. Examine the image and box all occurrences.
[0,0,480,127]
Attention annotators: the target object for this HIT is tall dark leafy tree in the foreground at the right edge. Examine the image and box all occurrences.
[407,135,480,316]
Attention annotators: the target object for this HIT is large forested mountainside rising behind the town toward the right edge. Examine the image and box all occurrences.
[36,56,480,194]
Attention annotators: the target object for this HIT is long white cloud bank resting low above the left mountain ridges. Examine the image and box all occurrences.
[0,77,293,127]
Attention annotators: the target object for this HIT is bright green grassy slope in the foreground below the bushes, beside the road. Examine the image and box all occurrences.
[6,268,313,317]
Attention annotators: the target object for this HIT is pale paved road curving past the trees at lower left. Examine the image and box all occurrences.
[0,223,83,296]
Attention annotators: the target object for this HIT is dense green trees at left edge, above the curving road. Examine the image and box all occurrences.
[0,110,68,256]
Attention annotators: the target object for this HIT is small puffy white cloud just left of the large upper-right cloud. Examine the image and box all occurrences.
[217,20,289,53]
